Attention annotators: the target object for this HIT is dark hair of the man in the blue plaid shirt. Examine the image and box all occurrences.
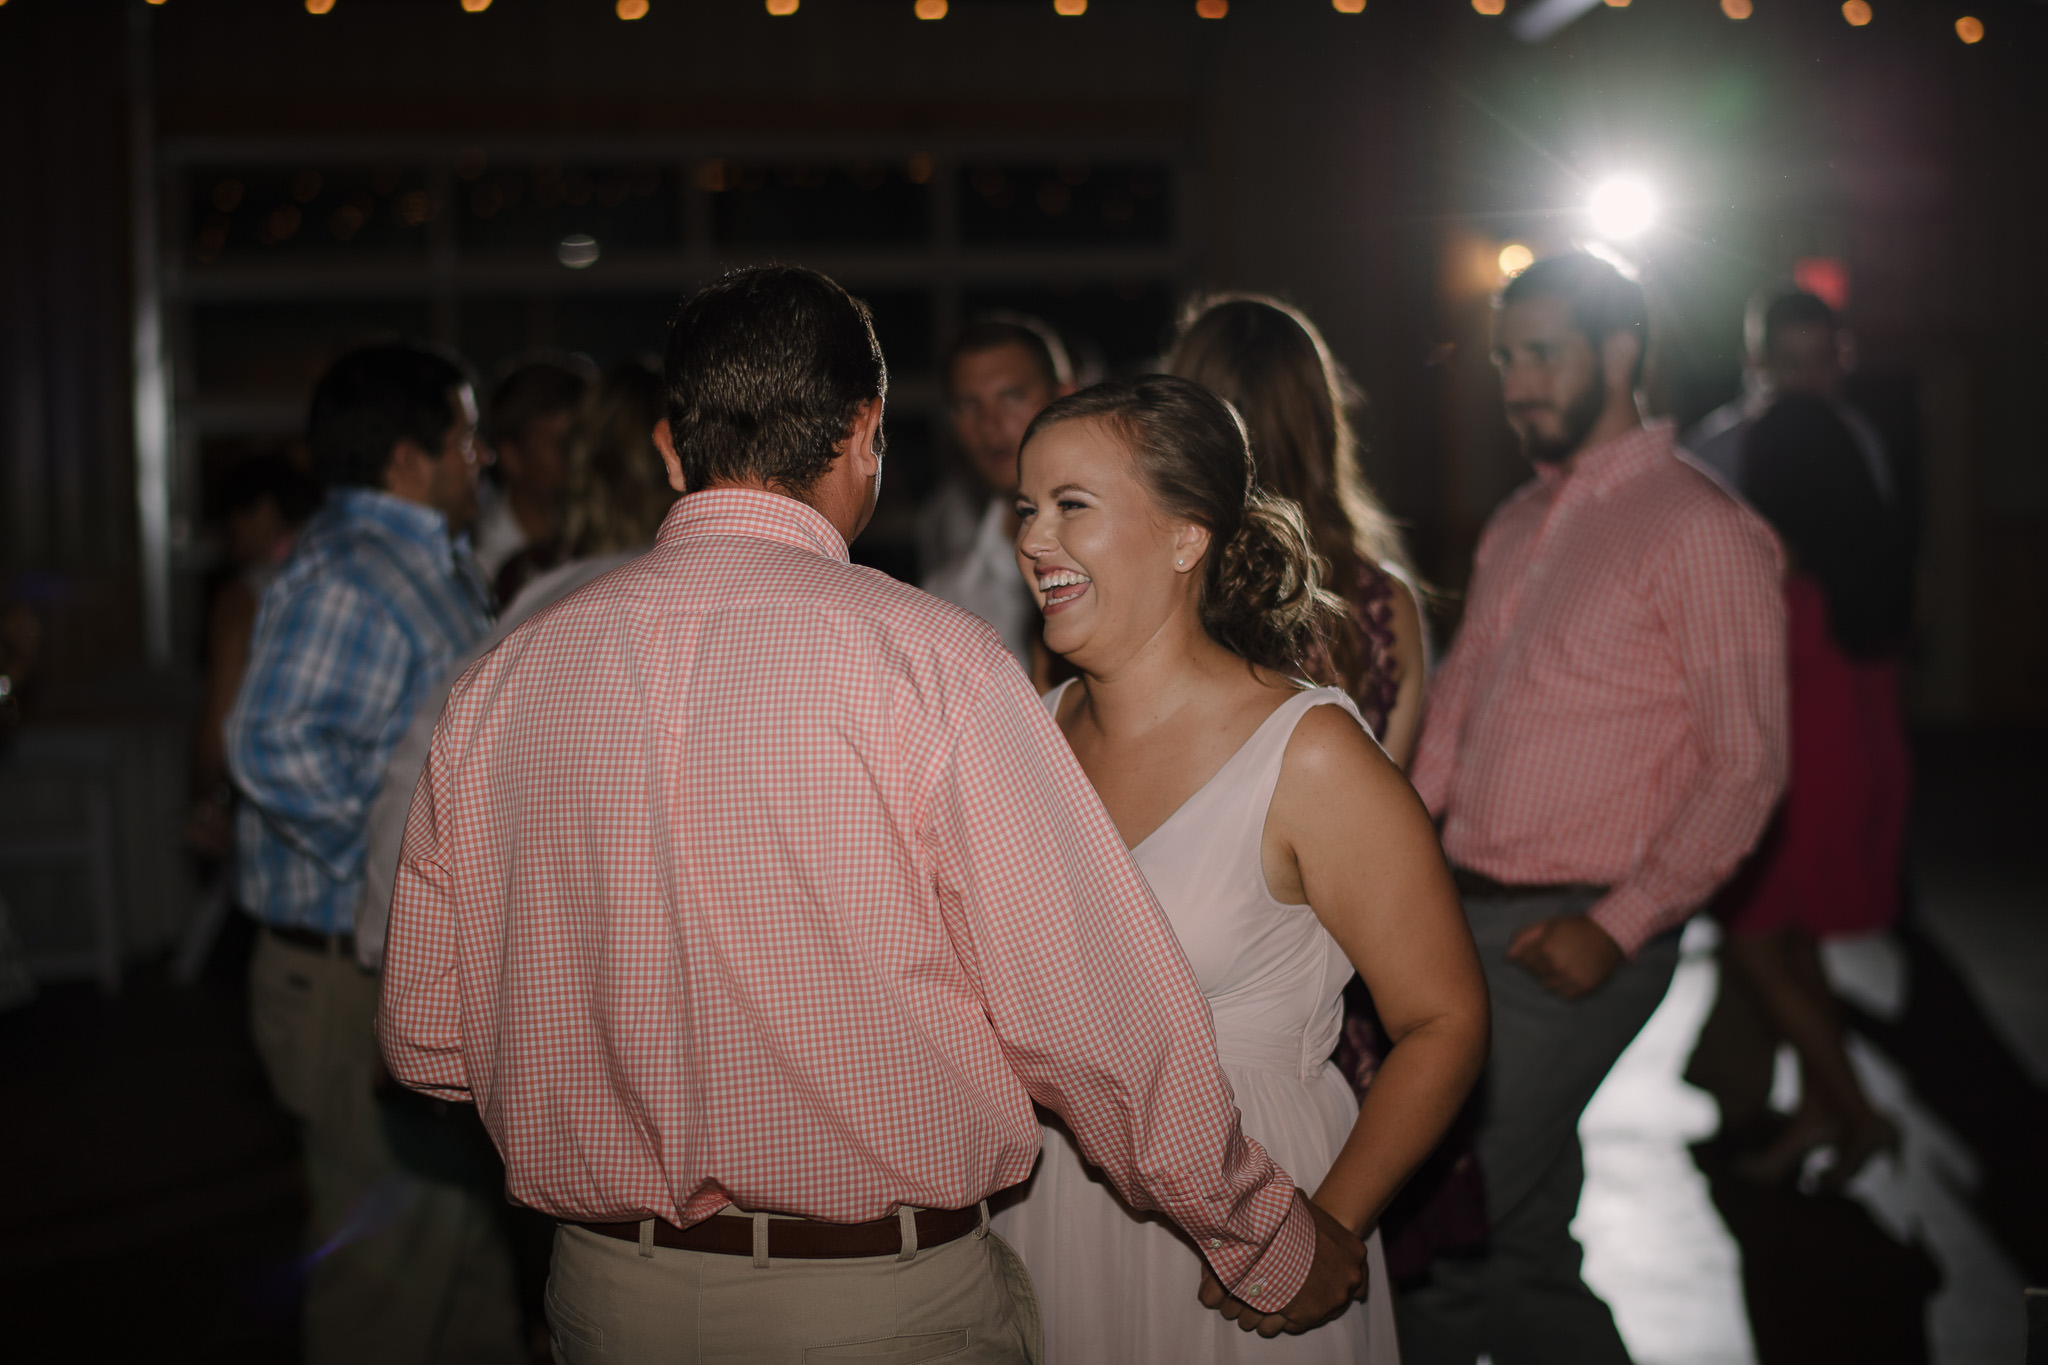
[305,344,471,489]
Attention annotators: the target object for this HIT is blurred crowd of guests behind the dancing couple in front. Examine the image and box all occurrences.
[0,256,1919,1365]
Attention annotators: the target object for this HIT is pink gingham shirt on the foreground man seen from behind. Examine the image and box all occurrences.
[377,489,1315,1310]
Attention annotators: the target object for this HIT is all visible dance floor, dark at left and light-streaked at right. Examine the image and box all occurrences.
[0,737,2048,1365]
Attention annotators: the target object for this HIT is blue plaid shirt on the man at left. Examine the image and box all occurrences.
[227,487,489,933]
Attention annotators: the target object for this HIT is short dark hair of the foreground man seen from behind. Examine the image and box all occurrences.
[666,266,889,495]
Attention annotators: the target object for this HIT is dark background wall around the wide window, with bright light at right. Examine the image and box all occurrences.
[0,0,2048,724]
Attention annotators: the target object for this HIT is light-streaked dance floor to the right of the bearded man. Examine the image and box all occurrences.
[1575,737,2048,1365]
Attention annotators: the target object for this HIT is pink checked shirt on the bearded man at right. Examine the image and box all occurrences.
[1415,422,1790,958]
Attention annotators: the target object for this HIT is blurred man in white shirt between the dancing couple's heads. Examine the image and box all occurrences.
[918,313,1073,671]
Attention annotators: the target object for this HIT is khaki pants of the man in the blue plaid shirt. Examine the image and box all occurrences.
[250,933,526,1365]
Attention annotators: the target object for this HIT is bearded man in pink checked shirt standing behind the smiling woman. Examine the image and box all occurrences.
[1397,256,1788,1365]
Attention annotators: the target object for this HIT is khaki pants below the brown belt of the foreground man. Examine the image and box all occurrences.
[547,1224,1038,1365]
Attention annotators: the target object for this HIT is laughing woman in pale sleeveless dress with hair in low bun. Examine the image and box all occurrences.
[995,377,1487,1365]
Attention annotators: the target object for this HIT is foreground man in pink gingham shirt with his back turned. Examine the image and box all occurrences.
[379,266,1364,1365]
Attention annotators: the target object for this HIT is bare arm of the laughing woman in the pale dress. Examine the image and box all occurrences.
[1266,706,1487,1234]
